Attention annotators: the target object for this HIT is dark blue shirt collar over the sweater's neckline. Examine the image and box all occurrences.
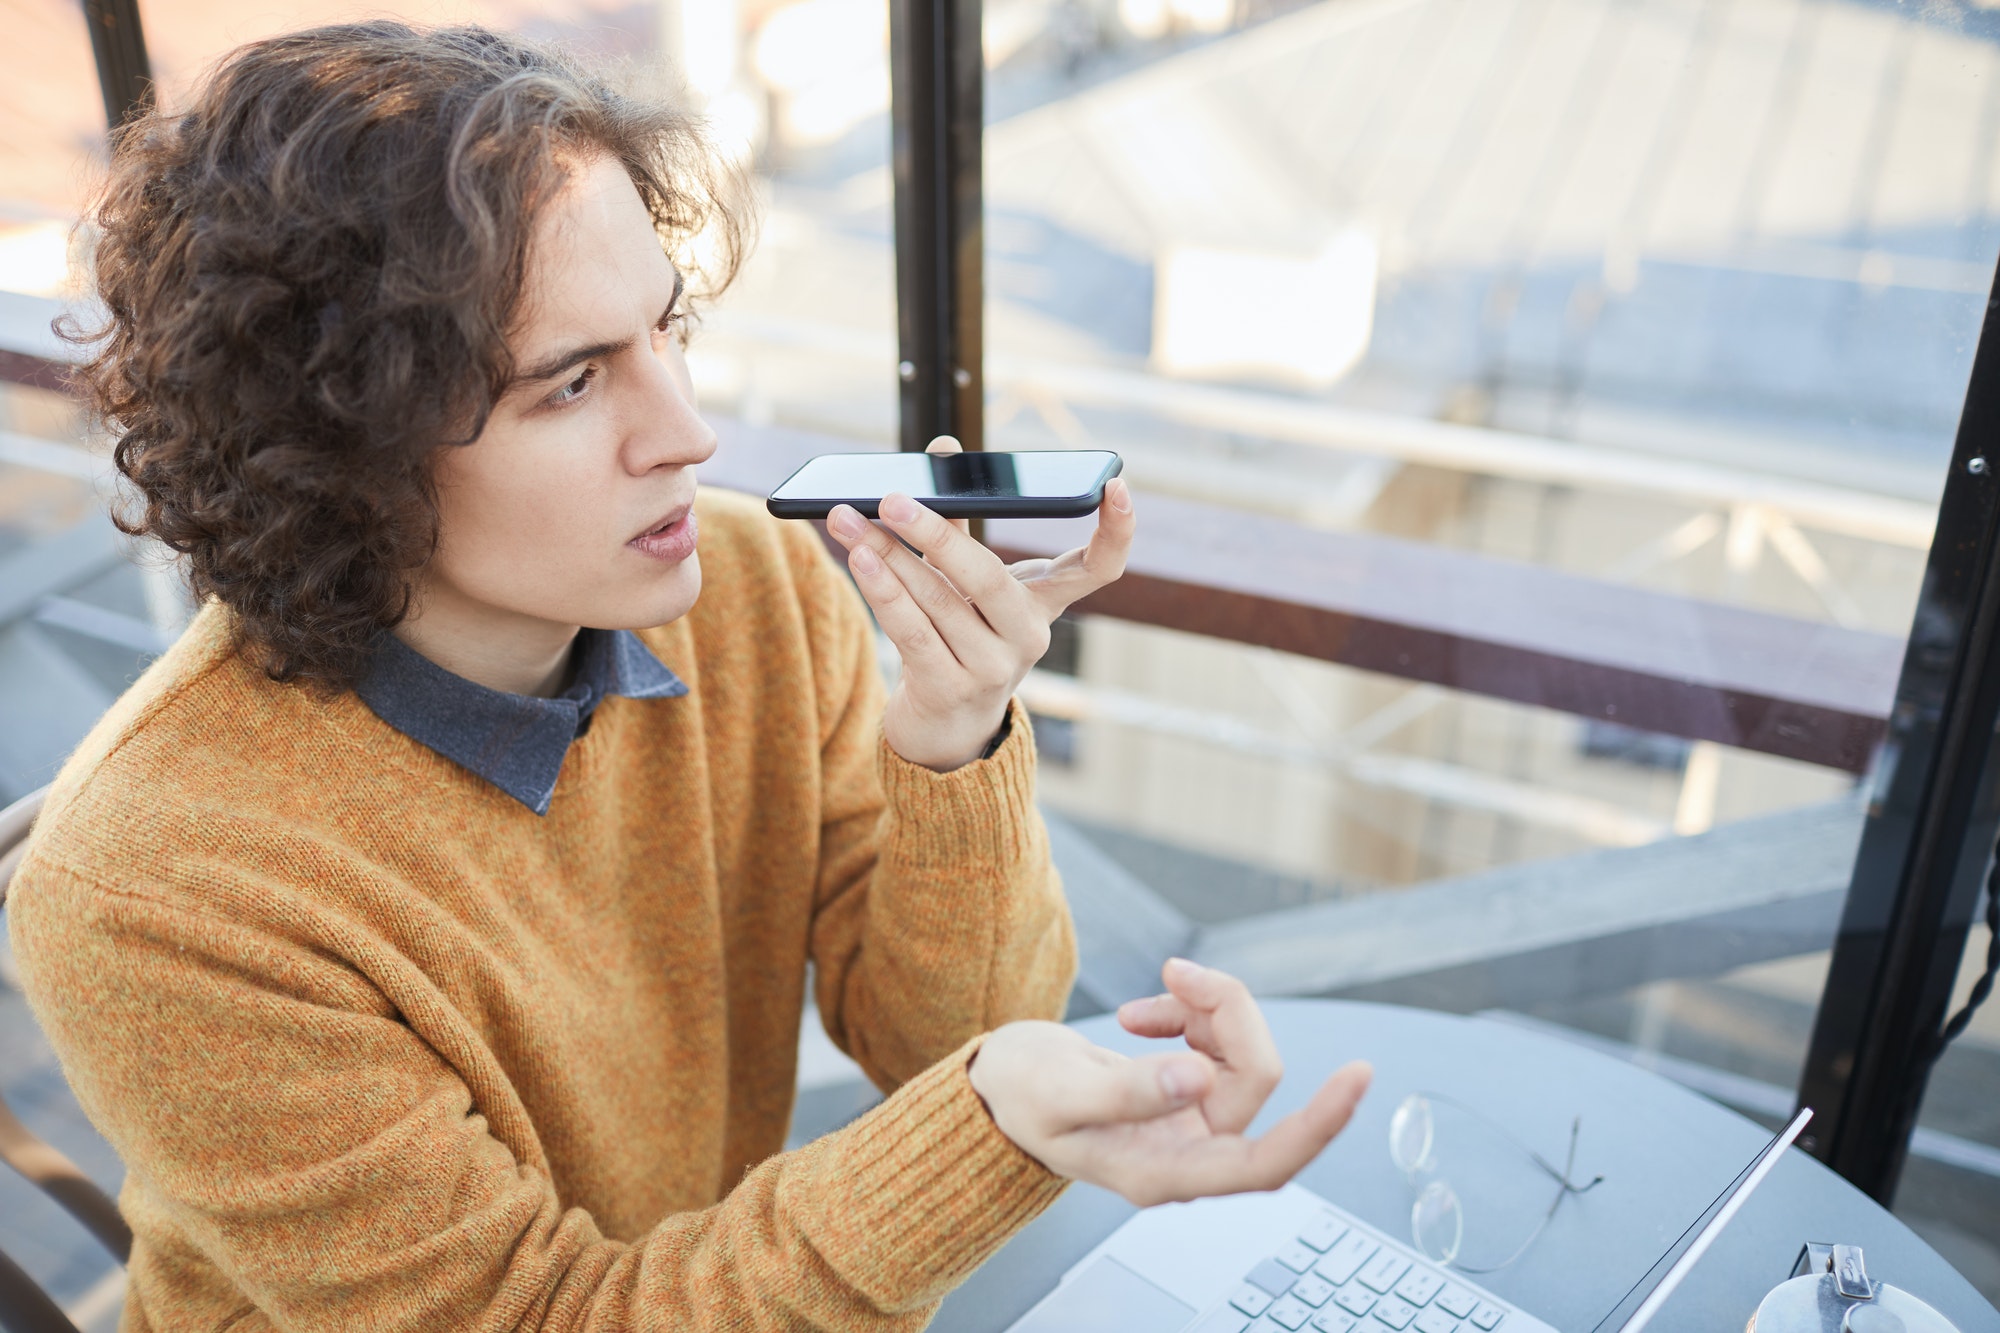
[354,628,688,815]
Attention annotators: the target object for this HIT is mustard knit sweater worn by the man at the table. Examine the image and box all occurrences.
[8,492,1074,1333]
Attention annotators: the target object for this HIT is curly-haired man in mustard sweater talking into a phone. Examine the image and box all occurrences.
[10,24,1366,1333]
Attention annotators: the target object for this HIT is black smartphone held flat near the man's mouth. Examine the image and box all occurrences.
[766,448,1124,518]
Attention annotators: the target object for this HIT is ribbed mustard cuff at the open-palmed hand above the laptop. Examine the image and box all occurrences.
[812,1037,1066,1309]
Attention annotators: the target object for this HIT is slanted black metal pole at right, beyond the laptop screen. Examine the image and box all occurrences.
[1798,264,2000,1203]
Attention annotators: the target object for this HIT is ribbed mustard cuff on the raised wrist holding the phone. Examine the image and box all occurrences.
[876,699,1040,867]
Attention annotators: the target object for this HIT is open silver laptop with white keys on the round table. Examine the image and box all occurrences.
[1008,1111,1812,1333]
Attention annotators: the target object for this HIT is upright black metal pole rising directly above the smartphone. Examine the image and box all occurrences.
[890,0,986,450]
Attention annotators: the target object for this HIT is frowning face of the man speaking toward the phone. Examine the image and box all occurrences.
[418,156,716,628]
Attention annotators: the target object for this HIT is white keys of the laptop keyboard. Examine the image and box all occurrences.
[1188,1213,1510,1333]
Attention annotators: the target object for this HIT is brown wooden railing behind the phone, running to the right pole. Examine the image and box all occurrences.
[702,418,1902,773]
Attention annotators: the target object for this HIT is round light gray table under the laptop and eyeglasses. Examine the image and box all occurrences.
[932,1001,2000,1333]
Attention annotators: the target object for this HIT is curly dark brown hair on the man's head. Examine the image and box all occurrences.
[62,22,746,689]
